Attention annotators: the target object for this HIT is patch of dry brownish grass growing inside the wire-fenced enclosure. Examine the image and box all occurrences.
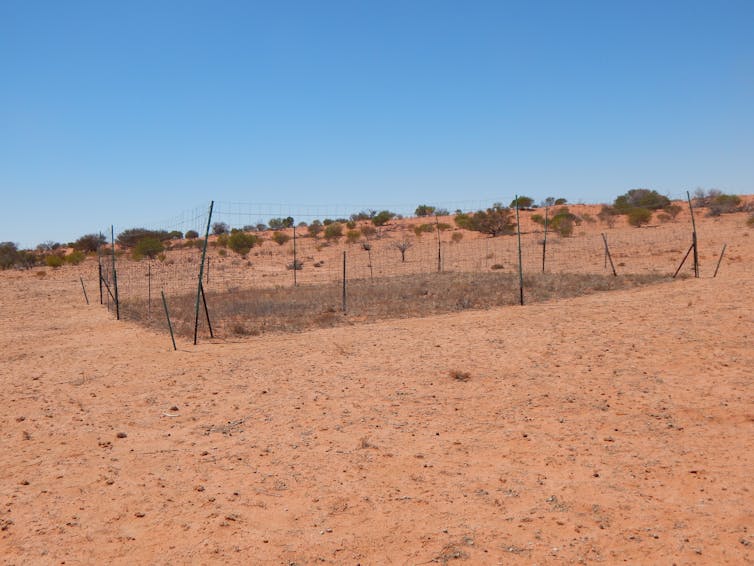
[121,272,667,337]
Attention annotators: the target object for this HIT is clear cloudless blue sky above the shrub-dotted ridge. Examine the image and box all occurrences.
[0,0,754,246]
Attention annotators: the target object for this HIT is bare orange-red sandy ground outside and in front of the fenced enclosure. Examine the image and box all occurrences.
[0,212,754,565]
